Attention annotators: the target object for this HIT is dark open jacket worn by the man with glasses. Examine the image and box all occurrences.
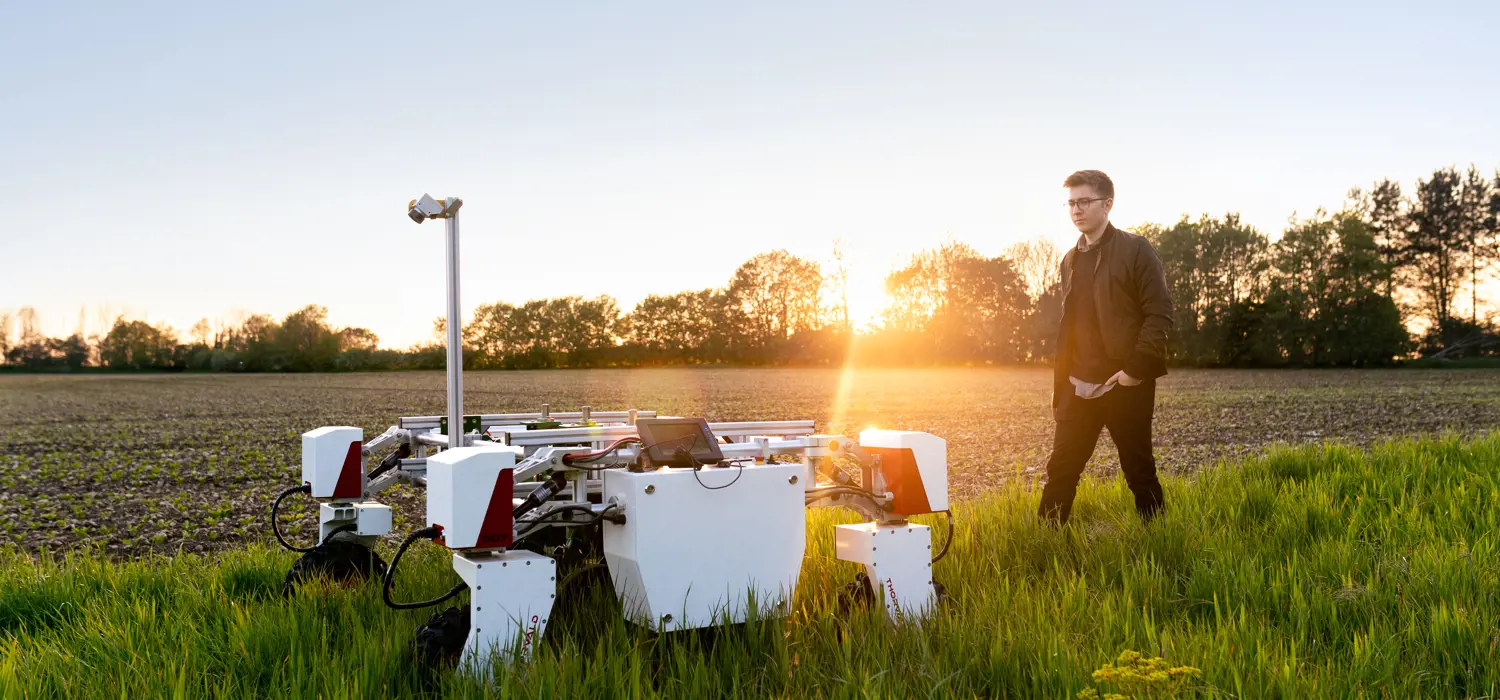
[1052,223,1172,420]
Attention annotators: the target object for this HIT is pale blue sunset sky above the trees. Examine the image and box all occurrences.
[0,0,1500,346]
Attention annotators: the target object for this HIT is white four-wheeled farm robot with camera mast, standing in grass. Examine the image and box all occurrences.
[272,195,953,672]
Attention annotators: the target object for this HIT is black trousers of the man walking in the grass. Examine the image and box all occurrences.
[1038,381,1164,523]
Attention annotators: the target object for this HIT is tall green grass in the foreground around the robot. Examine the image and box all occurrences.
[0,433,1500,699]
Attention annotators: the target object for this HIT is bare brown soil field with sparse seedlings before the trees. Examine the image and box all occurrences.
[0,367,1500,558]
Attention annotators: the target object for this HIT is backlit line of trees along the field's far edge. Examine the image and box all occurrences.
[0,166,1500,372]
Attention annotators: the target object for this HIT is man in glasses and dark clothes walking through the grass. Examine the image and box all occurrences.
[1038,171,1172,525]
